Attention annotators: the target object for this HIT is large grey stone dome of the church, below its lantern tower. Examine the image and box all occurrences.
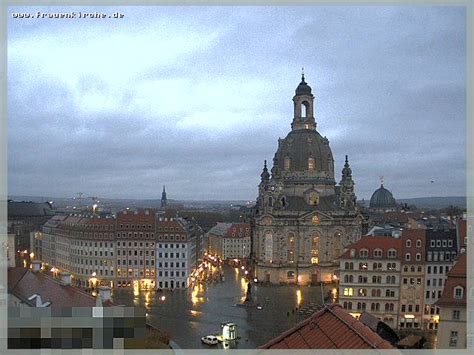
[273,129,334,177]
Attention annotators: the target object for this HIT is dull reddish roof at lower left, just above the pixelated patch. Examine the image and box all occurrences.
[8,267,115,308]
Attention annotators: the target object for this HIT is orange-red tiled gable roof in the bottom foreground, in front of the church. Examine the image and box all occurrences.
[259,304,394,349]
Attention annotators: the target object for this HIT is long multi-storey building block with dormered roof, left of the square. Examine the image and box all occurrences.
[31,209,203,289]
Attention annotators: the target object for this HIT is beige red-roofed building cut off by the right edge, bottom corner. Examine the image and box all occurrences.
[436,253,467,349]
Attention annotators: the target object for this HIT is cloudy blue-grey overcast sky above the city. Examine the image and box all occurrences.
[8,6,466,200]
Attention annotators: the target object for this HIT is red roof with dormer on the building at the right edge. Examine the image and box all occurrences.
[436,253,467,307]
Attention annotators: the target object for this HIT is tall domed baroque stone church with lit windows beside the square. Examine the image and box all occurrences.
[252,74,365,285]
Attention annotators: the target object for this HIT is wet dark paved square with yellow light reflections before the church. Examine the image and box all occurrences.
[114,265,330,349]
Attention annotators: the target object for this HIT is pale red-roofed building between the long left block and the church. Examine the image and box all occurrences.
[207,223,250,260]
